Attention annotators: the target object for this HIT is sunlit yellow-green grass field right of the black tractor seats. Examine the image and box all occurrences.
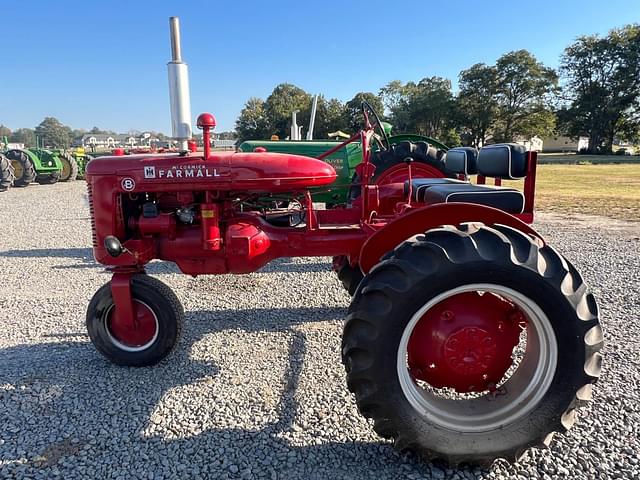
[505,164,640,222]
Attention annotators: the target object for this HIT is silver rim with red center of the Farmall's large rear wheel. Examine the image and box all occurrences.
[396,283,558,432]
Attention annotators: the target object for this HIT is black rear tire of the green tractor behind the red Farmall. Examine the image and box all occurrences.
[349,140,454,203]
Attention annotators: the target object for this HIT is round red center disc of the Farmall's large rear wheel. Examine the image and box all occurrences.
[408,292,525,393]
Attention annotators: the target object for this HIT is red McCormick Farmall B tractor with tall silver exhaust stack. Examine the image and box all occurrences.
[87,19,603,465]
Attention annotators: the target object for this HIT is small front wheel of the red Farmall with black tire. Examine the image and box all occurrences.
[86,274,184,367]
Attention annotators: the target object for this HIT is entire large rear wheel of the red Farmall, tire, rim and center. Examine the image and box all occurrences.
[342,224,603,466]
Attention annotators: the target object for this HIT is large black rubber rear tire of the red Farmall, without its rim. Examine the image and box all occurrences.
[342,224,603,465]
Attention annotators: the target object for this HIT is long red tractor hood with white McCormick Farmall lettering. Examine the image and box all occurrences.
[87,152,336,192]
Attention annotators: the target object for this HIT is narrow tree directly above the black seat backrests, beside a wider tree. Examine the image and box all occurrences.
[456,63,498,148]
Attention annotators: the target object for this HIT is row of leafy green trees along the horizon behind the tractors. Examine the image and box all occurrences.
[236,24,640,153]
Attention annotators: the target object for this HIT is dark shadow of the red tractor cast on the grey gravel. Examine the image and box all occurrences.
[0,307,482,479]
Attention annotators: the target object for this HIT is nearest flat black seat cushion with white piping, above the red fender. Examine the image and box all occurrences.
[423,183,524,213]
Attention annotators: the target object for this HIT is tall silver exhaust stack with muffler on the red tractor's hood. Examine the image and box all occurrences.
[167,17,192,152]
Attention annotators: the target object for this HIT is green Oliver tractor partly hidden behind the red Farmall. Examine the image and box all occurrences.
[238,128,451,205]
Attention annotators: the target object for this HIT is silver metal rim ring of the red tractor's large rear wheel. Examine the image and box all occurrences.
[397,283,558,433]
